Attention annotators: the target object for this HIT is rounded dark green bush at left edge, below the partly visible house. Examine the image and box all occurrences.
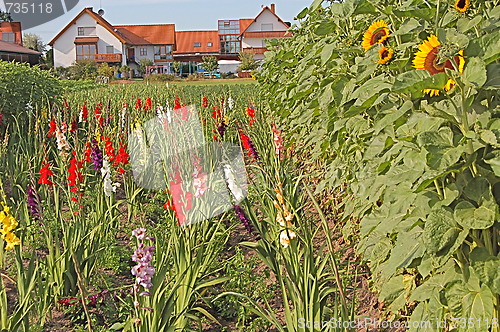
[0,61,61,115]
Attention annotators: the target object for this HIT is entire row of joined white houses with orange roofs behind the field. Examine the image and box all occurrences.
[49,4,290,73]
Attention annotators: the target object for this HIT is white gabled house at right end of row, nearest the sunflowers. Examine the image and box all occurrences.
[239,4,291,60]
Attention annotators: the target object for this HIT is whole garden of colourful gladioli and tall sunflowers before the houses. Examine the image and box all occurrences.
[0,0,500,332]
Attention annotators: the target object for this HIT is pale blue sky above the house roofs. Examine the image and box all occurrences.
[24,0,312,43]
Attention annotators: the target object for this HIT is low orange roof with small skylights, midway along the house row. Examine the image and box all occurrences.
[174,30,219,54]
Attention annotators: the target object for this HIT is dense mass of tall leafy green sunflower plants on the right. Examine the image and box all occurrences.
[261,0,500,331]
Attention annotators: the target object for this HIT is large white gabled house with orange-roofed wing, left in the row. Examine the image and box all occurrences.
[49,7,176,75]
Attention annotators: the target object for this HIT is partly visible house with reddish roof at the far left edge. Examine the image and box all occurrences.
[0,22,41,65]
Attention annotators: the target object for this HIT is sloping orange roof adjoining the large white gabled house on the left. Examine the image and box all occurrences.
[114,24,175,45]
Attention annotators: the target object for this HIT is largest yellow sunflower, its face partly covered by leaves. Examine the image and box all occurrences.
[413,35,465,97]
